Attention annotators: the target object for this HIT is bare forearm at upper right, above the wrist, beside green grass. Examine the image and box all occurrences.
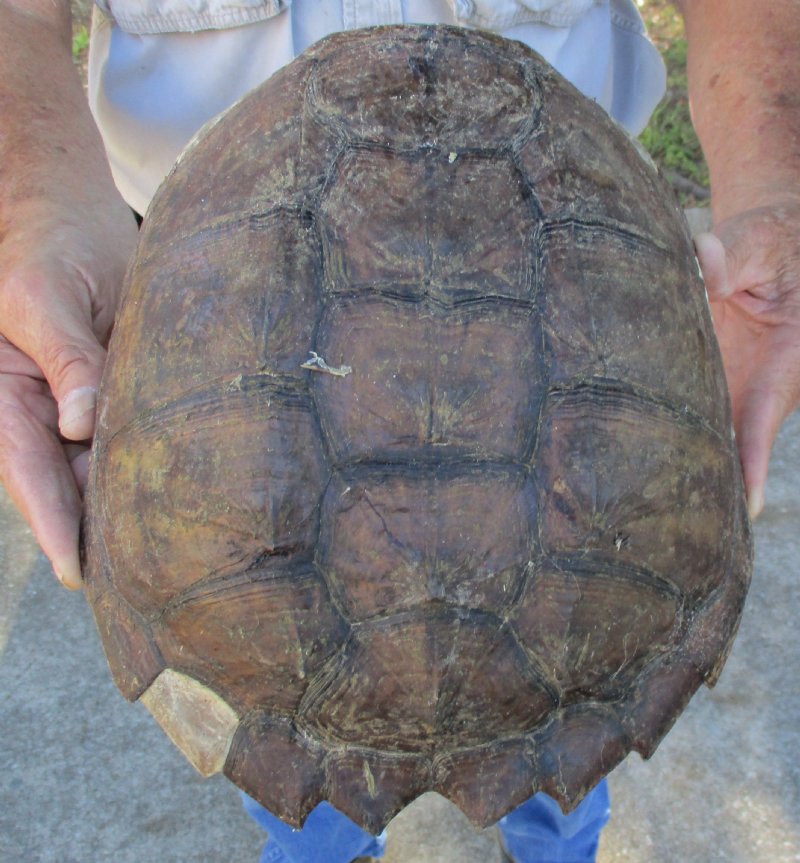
[677,0,800,222]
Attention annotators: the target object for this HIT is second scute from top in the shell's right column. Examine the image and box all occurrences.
[542,222,730,434]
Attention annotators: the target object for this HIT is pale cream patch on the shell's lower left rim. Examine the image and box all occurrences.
[139,668,239,776]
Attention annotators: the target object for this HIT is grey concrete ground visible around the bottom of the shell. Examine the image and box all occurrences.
[0,414,800,863]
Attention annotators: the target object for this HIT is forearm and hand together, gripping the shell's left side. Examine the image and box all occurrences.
[0,0,137,588]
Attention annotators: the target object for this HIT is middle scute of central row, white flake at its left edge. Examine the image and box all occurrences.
[312,295,545,463]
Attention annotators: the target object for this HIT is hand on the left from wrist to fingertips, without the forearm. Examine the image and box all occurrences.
[0,201,136,589]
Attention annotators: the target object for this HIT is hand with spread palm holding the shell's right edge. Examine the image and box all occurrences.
[695,197,800,518]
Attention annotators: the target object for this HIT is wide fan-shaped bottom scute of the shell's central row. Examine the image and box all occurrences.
[301,611,554,757]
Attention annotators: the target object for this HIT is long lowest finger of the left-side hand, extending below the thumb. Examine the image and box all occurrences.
[0,398,81,590]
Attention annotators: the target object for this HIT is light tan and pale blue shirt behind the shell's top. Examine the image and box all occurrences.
[89,0,666,213]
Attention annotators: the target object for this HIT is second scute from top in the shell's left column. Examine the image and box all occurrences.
[99,210,321,430]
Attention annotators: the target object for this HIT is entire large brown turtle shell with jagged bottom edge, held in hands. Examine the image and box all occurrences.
[85,26,751,831]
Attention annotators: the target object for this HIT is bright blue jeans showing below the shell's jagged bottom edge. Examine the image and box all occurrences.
[242,780,609,863]
